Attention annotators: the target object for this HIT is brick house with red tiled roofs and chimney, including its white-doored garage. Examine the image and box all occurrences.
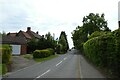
[2,27,41,55]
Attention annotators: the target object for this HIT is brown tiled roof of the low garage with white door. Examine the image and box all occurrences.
[0,36,27,45]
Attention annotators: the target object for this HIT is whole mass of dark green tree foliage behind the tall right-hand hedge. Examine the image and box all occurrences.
[72,13,110,52]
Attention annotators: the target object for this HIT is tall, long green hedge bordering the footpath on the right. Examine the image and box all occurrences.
[83,32,120,77]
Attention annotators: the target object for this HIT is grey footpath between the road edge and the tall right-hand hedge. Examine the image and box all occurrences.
[79,55,106,79]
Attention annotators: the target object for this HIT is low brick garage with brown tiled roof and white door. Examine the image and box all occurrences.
[0,36,27,55]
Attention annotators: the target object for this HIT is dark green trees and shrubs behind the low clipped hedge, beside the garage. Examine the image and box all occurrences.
[28,33,57,53]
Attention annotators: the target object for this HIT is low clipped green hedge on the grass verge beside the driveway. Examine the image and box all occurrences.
[33,49,54,58]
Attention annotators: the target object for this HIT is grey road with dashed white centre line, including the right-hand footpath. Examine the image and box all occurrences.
[2,50,104,80]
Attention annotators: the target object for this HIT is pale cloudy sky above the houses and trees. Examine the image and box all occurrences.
[0,0,120,48]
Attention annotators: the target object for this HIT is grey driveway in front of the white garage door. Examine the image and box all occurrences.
[12,56,36,72]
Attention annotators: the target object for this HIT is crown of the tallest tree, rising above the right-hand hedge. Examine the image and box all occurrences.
[82,13,110,34]
